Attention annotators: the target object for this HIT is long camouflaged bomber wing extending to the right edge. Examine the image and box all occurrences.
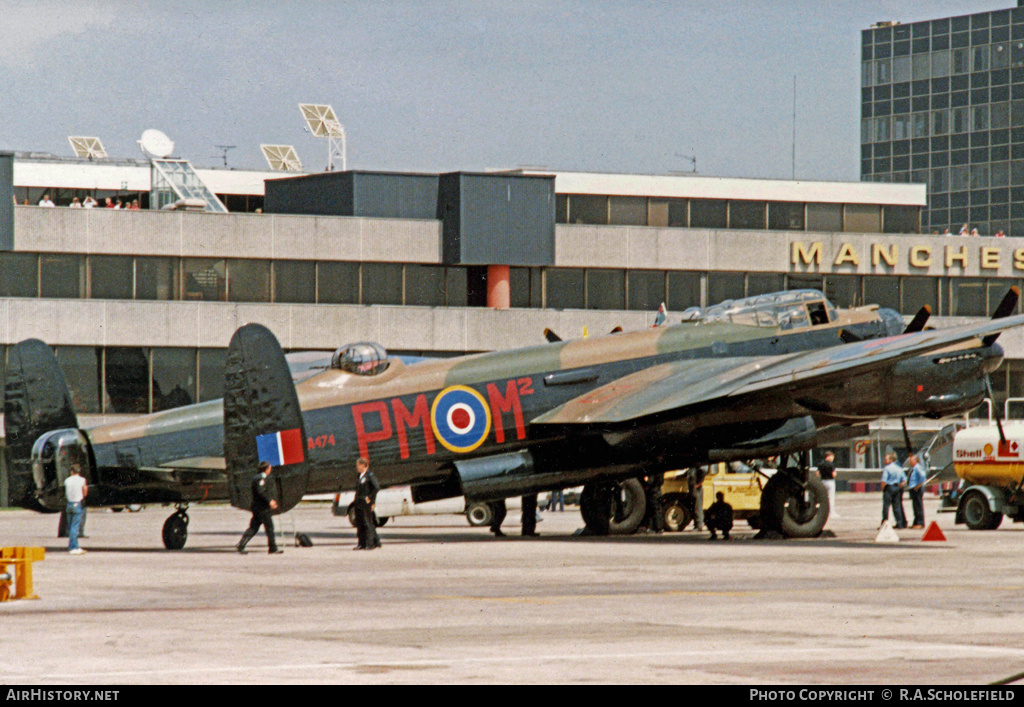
[531,315,1024,424]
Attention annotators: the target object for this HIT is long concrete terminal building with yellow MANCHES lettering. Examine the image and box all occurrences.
[0,147,1024,506]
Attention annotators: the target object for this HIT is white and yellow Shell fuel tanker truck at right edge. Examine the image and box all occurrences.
[953,423,1024,530]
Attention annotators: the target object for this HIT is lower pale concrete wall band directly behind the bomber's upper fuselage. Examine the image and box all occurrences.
[0,298,655,351]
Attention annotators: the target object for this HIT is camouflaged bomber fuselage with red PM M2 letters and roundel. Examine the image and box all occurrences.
[79,307,896,505]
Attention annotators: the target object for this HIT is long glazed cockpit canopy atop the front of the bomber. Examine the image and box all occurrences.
[683,290,838,329]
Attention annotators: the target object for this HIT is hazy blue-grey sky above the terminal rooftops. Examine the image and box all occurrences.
[0,0,1014,180]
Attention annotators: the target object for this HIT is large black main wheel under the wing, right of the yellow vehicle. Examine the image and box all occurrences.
[761,471,828,538]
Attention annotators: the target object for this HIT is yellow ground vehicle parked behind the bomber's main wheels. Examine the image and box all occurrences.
[662,463,774,531]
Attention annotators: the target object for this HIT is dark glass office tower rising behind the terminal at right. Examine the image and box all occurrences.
[860,7,1024,237]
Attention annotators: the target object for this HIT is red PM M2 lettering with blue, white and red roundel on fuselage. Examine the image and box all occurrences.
[352,378,534,459]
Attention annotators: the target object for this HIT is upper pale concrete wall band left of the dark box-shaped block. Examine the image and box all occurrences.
[14,208,441,263]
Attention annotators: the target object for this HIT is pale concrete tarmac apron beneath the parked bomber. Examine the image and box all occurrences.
[0,494,1024,685]
